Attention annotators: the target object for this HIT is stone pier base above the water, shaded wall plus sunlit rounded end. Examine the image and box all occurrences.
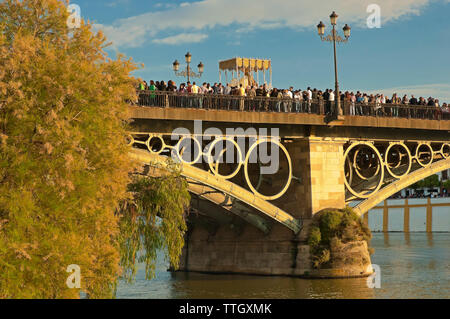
[179,221,372,278]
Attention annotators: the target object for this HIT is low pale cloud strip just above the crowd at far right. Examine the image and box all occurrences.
[368,83,450,104]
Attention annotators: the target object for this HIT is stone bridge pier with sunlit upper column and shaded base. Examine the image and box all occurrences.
[180,138,361,277]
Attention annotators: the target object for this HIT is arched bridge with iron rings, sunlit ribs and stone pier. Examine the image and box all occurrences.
[129,96,450,274]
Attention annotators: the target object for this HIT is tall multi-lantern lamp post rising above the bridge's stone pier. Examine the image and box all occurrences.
[317,11,351,116]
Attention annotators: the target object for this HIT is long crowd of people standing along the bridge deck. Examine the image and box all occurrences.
[138,80,450,116]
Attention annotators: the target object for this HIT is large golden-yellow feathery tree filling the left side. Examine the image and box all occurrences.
[0,0,189,298]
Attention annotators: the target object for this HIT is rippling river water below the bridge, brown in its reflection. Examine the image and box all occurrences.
[117,233,450,299]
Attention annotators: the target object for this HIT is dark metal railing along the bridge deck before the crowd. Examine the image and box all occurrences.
[135,91,450,120]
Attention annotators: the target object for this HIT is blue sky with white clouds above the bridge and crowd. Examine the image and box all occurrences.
[71,0,450,102]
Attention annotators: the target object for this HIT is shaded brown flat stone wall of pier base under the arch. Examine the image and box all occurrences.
[180,225,311,276]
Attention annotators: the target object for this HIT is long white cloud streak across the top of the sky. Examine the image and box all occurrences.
[95,0,440,47]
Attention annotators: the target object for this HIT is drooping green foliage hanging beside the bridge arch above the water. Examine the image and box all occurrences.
[120,162,190,282]
